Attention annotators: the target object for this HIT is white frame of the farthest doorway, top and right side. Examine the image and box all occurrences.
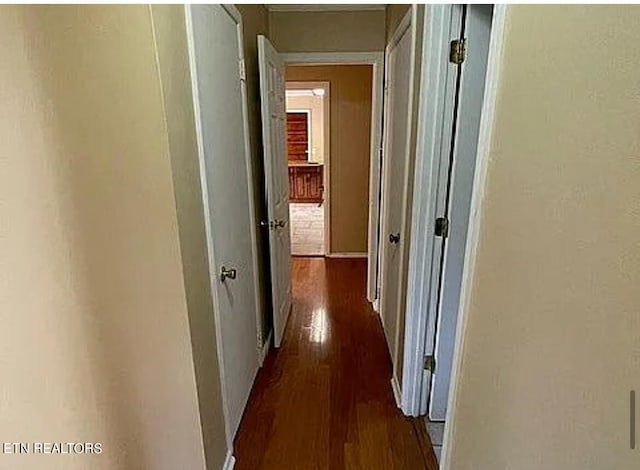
[288,82,331,256]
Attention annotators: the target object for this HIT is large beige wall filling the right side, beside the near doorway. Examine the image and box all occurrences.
[450,6,640,470]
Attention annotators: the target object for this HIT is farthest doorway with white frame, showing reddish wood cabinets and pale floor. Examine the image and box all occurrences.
[286,81,330,256]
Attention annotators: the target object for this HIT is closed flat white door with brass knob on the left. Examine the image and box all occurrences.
[186,5,259,439]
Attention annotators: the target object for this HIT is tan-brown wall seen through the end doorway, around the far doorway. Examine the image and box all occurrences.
[286,65,373,253]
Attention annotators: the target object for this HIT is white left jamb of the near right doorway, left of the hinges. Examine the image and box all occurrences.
[400,5,462,416]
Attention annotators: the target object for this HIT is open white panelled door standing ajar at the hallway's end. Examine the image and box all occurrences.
[258,36,291,347]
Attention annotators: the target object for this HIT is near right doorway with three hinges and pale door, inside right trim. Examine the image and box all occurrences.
[402,5,502,462]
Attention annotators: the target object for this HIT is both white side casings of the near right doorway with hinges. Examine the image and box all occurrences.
[401,0,507,462]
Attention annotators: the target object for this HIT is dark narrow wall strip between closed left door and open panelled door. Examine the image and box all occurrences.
[235,4,273,341]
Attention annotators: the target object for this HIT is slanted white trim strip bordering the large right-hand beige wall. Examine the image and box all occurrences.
[440,4,508,470]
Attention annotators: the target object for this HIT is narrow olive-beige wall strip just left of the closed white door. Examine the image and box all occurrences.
[151,5,227,469]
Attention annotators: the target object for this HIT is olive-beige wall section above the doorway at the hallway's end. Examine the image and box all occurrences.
[269,10,385,52]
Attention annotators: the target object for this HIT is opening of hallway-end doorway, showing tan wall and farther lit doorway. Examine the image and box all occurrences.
[283,62,376,270]
